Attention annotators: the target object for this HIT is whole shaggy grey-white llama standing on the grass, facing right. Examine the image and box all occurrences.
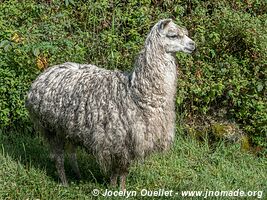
[26,19,195,190]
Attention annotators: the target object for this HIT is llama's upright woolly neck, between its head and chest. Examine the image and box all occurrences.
[131,47,177,107]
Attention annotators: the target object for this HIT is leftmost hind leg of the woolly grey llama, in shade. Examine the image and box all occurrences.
[48,137,68,186]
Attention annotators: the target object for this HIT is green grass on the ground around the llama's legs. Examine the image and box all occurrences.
[0,128,267,199]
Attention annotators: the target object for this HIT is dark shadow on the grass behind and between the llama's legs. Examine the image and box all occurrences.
[0,125,109,185]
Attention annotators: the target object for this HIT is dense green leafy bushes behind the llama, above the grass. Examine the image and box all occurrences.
[0,0,267,146]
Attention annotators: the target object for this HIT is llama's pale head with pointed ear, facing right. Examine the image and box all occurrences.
[151,19,195,53]
